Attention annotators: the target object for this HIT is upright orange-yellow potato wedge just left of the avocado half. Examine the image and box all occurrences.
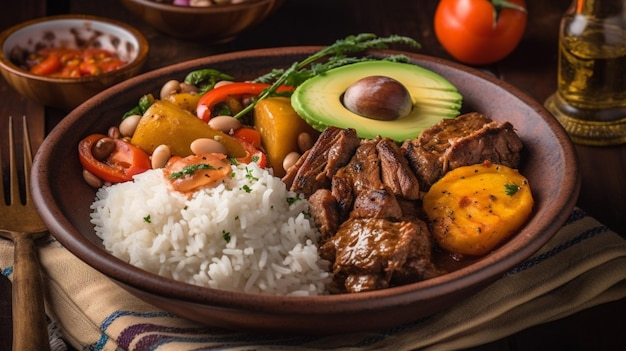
[254,97,319,177]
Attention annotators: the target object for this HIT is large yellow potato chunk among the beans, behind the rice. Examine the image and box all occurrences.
[130,100,246,158]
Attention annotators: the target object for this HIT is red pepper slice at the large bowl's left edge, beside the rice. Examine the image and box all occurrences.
[78,134,152,183]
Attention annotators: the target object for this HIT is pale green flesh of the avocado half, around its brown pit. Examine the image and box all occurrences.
[291,61,462,142]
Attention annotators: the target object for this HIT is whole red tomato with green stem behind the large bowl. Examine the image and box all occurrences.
[435,0,526,65]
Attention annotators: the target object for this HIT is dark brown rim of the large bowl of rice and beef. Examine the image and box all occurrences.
[32,46,581,315]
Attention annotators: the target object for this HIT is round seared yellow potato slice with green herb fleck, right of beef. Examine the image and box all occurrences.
[423,162,534,256]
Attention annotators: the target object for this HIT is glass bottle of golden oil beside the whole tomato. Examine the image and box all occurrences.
[545,0,626,146]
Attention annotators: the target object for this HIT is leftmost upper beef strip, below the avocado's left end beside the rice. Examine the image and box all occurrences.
[283,127,361,198]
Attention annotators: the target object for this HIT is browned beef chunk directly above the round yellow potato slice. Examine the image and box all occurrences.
[402,112,522,191]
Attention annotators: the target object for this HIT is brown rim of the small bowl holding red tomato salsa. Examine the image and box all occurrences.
[0,14,150,84]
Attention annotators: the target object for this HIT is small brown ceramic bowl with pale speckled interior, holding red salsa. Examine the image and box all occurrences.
[0,15,149,111]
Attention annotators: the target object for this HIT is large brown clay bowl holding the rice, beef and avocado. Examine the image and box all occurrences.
[28,47,580,334]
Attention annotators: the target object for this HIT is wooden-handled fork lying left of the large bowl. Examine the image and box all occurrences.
[0,117,50,350]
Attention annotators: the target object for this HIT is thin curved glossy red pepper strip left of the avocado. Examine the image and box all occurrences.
[196,82,294,122]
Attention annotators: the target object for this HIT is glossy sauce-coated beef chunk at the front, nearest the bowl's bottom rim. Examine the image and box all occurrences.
[320,218,442,293]
